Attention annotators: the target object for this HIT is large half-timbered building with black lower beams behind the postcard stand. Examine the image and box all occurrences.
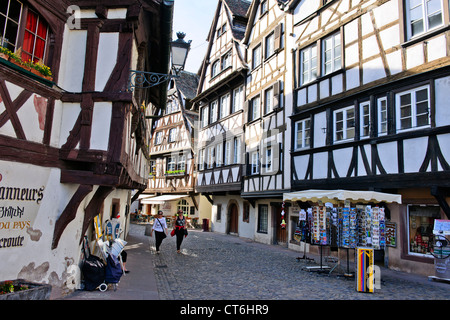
[286,0,450,275]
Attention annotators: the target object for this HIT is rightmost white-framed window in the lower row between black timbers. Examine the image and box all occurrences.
[395,86,430,131]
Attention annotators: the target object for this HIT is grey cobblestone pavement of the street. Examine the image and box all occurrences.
[139,227,450,300]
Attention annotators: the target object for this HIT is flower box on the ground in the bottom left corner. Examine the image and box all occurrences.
[0,279,52,300]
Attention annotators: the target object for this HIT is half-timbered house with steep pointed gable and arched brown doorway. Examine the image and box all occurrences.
[194,0,254,237]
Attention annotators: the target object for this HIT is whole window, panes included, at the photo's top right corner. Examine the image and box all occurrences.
[406,0,443,39]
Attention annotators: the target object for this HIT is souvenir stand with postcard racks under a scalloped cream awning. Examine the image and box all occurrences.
[283,190,401,277]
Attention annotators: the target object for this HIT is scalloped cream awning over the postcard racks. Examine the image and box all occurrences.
[283,190,402,204]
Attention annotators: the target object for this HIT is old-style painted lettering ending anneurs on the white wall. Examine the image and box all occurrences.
[0,165,45,252]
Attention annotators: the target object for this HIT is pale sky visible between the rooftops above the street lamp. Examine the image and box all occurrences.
[172,0,218,73]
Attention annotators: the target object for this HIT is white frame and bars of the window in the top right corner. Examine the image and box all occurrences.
[405,0,444,39]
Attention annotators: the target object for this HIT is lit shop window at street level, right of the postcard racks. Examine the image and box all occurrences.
[408,205,441,257]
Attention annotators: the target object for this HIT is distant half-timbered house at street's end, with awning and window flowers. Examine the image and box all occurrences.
[140,71,209,225]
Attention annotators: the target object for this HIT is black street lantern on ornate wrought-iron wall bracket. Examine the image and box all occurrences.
[128,32,192,91]
